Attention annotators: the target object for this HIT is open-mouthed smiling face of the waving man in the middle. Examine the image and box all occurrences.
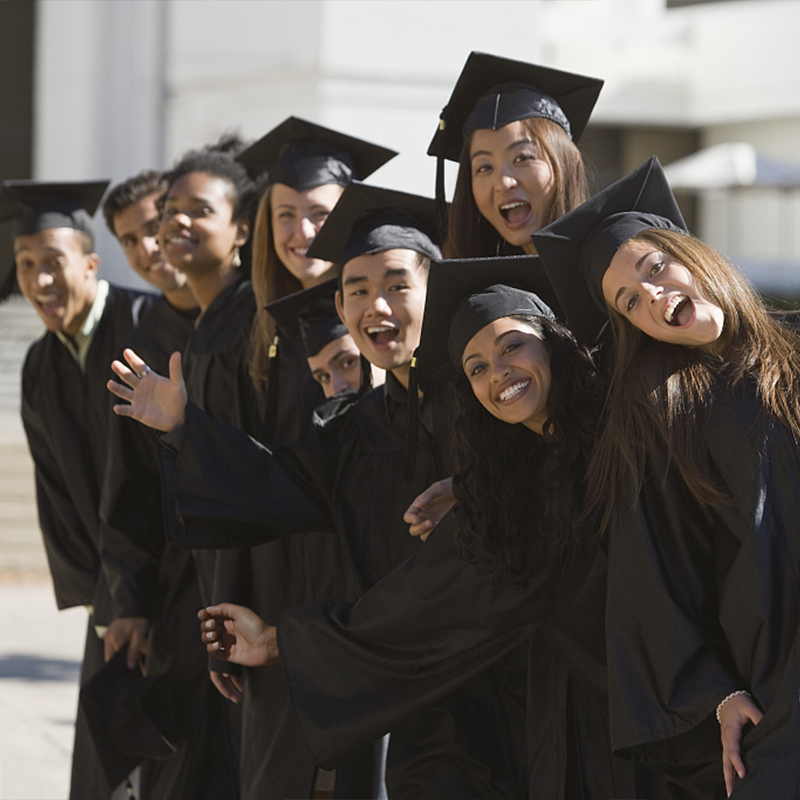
[336,250,428,386]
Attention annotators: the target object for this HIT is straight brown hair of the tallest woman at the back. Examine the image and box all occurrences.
[444,117,589,258]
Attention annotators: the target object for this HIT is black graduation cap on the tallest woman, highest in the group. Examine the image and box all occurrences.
[428,51,603,161]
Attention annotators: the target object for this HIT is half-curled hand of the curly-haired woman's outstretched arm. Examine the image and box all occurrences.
[197,603,280,667]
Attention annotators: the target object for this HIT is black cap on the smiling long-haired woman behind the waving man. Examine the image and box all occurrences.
[236,117,397,192]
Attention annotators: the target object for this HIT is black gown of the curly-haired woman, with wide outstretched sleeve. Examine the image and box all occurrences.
[278,517,646,800]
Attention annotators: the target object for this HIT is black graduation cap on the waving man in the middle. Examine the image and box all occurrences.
[306,181,441,271]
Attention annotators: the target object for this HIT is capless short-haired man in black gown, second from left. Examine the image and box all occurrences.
[100,171,241,800]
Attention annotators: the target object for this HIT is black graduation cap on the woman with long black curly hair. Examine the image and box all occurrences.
[415,255,558,382]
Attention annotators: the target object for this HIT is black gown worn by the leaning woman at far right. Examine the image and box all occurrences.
[607,388,800,798]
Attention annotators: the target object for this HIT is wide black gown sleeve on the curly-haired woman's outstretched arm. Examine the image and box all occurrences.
[278,517,595,766]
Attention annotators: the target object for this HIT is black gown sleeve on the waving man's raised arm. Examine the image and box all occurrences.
[159,403,337,549]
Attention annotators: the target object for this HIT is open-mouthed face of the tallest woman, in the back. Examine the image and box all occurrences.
[470,121,556,247]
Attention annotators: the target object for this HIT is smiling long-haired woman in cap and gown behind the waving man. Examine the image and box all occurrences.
[223,122,396,800]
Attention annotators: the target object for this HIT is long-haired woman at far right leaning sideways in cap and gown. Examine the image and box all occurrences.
[535,158,800,798]
